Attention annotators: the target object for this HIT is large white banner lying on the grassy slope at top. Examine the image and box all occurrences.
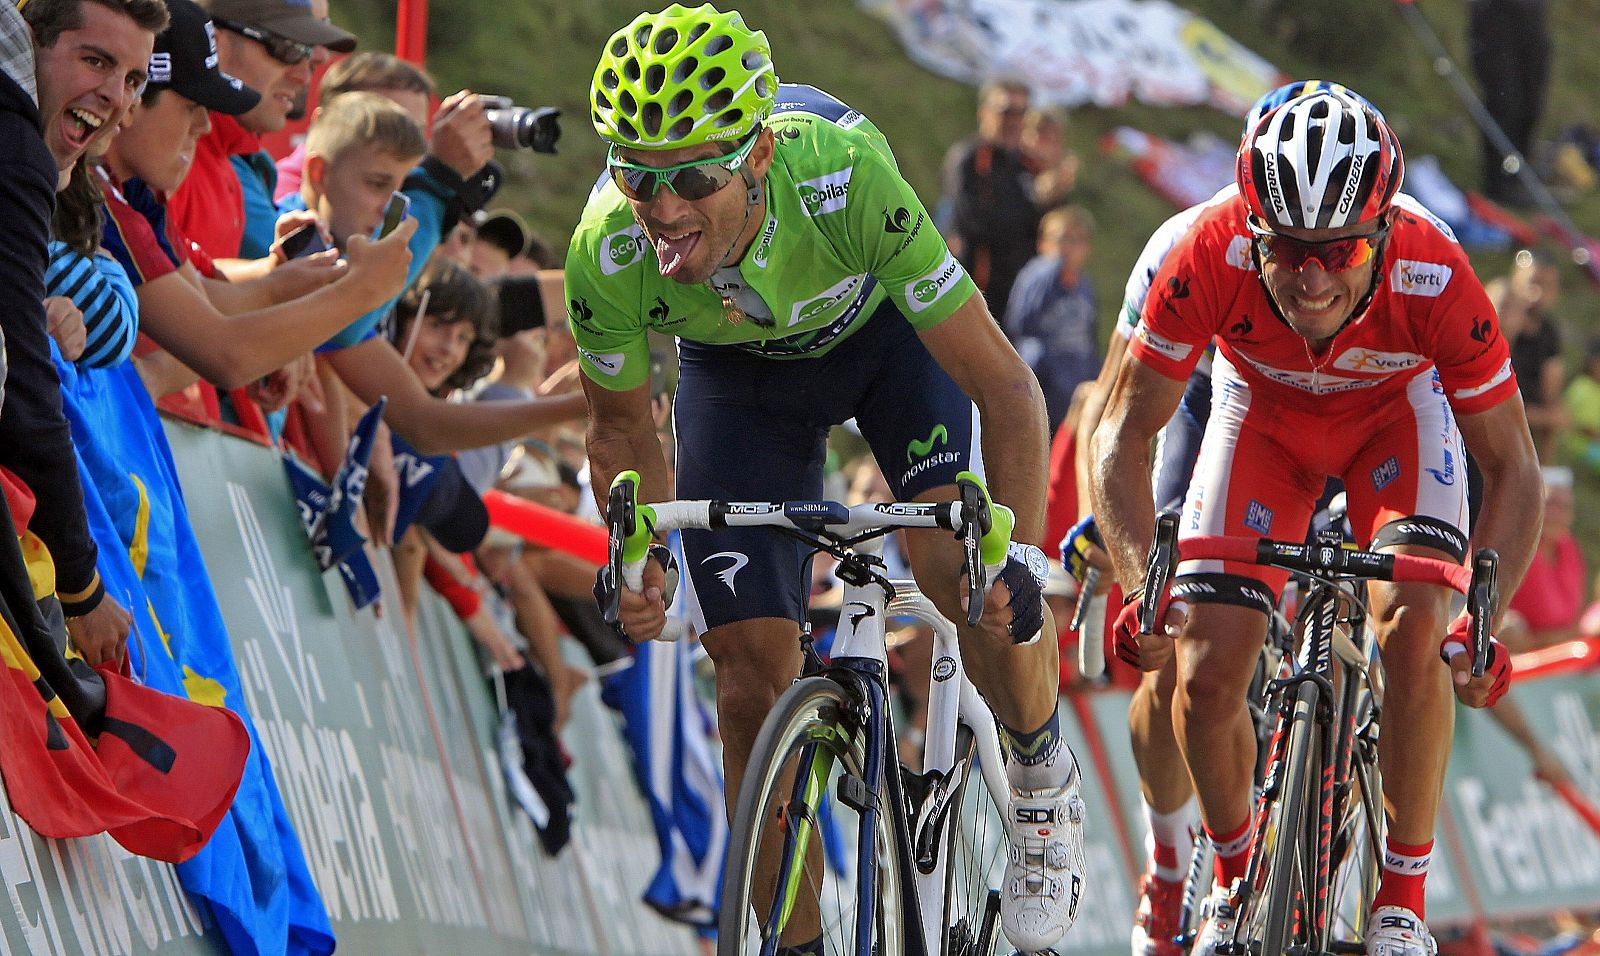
[858,0,1283,115]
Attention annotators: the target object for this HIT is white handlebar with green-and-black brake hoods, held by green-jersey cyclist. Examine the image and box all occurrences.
[602,472,1016,625]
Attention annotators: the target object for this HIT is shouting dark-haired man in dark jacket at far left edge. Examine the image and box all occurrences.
[0,0,166,663]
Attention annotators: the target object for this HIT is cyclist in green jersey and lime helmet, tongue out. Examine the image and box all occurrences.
[566,5,1083,954]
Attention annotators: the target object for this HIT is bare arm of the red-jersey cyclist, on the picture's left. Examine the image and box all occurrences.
[1088,353,1184,590]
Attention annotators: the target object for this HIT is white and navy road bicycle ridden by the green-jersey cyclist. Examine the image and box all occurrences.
[605,472,1013,956]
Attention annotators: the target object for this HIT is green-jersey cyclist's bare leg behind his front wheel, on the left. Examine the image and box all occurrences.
[701,617,822,945]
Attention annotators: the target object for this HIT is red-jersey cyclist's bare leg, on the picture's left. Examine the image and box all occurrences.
[1173,603,1267,887]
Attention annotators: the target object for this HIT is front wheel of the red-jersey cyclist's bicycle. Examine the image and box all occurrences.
[1245,681,1322,953]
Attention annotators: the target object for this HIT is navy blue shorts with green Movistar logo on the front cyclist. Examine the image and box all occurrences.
[672,302,982,633]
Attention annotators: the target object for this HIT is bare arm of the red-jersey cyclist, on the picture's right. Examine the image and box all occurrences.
[1456,392,1544,627]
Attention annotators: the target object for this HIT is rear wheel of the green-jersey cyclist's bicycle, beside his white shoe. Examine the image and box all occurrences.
[930,724,1006,956]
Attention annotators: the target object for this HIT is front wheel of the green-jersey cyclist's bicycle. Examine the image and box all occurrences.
[717,676,907,956]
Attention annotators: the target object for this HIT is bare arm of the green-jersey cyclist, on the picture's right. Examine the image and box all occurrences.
[921,296,1050,545]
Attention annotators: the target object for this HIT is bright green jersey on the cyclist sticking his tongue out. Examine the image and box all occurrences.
[566,85,978,390]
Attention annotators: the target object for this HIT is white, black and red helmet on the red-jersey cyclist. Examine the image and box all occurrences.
[1235,90,1405,229]
